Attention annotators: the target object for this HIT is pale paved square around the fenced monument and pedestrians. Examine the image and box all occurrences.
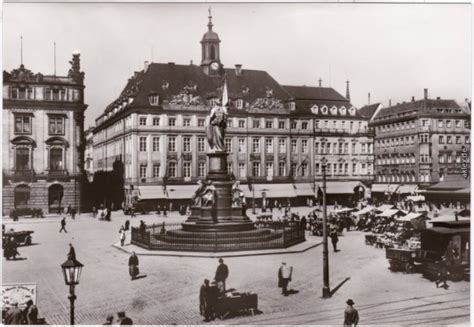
[2,208,470,326]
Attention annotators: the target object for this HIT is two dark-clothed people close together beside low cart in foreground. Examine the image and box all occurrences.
[199,258,229,322]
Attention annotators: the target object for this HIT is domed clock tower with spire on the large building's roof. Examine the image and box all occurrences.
[201,8,222,76]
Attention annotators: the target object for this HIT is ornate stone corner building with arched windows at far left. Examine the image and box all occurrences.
[2,53,87,215]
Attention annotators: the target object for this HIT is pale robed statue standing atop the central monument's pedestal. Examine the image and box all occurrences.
[206,100,227,152]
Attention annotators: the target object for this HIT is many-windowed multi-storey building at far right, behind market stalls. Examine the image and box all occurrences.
[369,89,470,193]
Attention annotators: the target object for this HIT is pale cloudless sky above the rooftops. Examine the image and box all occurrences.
[2,3,472,127]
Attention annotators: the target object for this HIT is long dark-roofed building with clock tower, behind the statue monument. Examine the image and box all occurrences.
[93,17,373,208]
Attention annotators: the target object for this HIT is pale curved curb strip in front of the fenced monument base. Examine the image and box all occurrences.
[112,238,323,259]
